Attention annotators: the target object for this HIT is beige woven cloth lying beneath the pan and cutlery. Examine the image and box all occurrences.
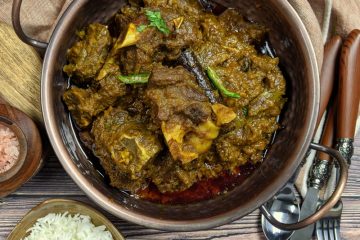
[0,0,360,199]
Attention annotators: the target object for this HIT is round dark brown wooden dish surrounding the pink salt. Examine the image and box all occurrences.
[0,104,43,197]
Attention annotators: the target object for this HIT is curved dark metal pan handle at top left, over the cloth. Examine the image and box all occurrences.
[11,0,48,52]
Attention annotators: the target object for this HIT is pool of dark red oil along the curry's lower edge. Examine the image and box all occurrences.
[137,164,260,204]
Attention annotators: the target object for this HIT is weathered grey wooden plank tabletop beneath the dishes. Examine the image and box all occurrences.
[0,134,360,240]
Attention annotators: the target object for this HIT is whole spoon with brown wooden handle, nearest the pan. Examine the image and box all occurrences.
[261,36,342,240]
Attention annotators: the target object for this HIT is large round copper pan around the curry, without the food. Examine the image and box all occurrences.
[13,0,328,230]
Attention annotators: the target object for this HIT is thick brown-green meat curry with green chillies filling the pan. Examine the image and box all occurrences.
[63,0,286,198]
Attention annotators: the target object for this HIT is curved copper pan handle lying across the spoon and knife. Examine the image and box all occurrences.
[260,143,348,231]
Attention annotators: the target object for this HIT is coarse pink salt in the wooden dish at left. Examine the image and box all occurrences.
[0,124,20,173]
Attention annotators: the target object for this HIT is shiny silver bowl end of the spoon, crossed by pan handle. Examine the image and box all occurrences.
[261,174,300,240]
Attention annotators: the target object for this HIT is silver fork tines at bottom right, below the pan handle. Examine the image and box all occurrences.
[316,200,343,240]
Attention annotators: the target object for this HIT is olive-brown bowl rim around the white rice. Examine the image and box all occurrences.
[7,199,125,240]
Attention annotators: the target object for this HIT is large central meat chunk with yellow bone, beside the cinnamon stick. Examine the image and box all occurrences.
[146,66,236,163]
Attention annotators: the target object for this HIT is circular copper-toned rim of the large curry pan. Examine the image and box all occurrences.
[41,0,319,231]
